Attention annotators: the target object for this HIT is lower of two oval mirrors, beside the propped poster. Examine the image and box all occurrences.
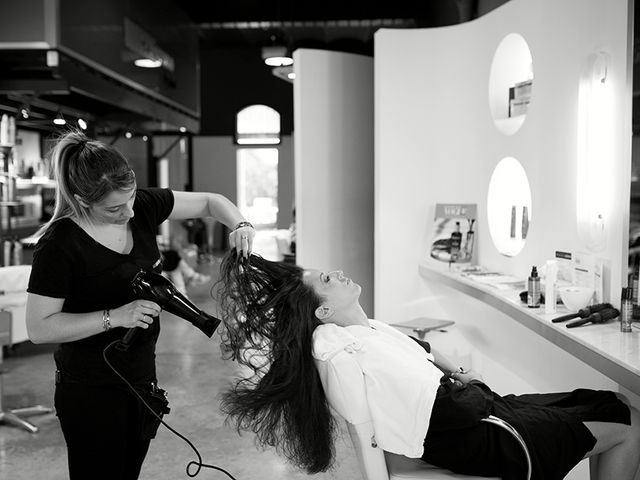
[487,157,531,257]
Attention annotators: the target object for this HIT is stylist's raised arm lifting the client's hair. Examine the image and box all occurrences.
[169,191,255,256]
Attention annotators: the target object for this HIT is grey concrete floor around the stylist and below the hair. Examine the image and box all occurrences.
[0,253,362,480]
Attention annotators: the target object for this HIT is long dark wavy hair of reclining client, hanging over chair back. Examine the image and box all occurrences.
[217,250,336,473]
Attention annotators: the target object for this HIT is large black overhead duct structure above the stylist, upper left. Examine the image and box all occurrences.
[0,0,200,134]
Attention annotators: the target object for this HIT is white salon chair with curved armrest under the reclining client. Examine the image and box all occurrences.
[316,342,531,480]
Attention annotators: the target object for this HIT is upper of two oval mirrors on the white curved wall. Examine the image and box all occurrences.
[489,33,533,135]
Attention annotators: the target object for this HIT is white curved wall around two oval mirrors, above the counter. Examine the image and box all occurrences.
[375,0,631,320]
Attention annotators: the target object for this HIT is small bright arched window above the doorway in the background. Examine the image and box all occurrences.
[236,105,280,145]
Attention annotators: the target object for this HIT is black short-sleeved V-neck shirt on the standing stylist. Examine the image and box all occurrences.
[27,188,174,385]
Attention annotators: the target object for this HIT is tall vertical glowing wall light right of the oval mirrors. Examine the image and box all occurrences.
[576,52,614,252]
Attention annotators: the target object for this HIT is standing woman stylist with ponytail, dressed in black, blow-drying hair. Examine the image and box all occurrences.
[26,132,255,480]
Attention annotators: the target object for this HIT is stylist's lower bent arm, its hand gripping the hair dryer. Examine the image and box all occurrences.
[26,293,161,343]
